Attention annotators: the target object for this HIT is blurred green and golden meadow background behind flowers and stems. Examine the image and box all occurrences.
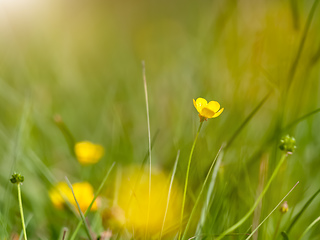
[0,0,320,240]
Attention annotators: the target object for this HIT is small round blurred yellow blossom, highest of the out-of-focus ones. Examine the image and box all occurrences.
[74,141,104,164]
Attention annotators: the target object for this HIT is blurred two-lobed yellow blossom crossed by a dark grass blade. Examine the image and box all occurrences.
[49,182,98,212]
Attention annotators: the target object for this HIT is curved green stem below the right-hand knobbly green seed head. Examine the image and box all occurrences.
[215,153,288,240]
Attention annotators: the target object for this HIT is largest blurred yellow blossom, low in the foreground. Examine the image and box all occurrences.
[117,167,182,238]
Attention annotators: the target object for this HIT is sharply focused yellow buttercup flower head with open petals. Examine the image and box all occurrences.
[193,98,224,122]
